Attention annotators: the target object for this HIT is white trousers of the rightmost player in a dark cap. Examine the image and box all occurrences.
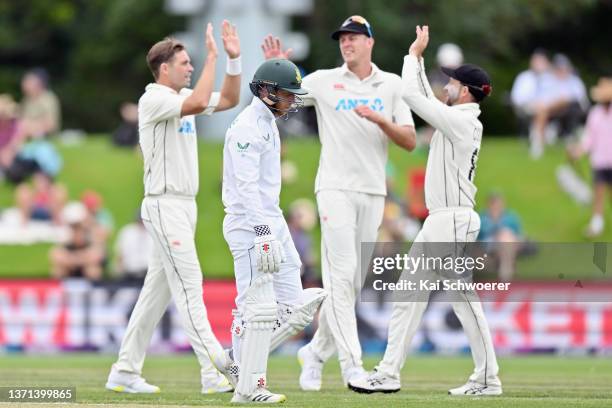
[377,207,499,384]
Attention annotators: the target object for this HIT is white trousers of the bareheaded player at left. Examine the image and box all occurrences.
[115,196,226,374]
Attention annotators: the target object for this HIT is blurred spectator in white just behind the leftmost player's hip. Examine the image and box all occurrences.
[115,211,153,282]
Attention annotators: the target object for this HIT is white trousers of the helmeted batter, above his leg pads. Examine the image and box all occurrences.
[223,214,302,313]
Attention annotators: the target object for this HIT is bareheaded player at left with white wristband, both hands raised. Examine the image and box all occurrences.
[106,21,241,393]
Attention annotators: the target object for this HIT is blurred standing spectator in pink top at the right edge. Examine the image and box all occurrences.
[570,78,612,237]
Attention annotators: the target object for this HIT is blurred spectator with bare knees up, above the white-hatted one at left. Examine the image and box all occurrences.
[15,171,68,225]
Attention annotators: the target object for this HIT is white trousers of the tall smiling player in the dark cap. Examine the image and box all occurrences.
[310,190,385,372]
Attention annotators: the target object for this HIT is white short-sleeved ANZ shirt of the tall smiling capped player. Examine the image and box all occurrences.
[302,64,414,195]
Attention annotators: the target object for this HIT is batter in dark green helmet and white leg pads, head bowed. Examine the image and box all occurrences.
[222,59,325,403]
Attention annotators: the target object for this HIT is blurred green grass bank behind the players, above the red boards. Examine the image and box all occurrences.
[0,137,612,278]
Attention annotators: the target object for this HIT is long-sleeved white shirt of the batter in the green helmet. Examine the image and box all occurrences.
[222,98,282,229]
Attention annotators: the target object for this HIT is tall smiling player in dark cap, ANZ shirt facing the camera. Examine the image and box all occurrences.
[262,16,416,391]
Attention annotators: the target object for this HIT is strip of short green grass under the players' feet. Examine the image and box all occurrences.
[0,354,612,408]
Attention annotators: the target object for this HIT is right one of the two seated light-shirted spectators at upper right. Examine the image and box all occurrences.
[529,54,588,159]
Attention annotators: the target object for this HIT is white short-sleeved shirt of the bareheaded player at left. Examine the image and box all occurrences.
[138,83,220,197]
